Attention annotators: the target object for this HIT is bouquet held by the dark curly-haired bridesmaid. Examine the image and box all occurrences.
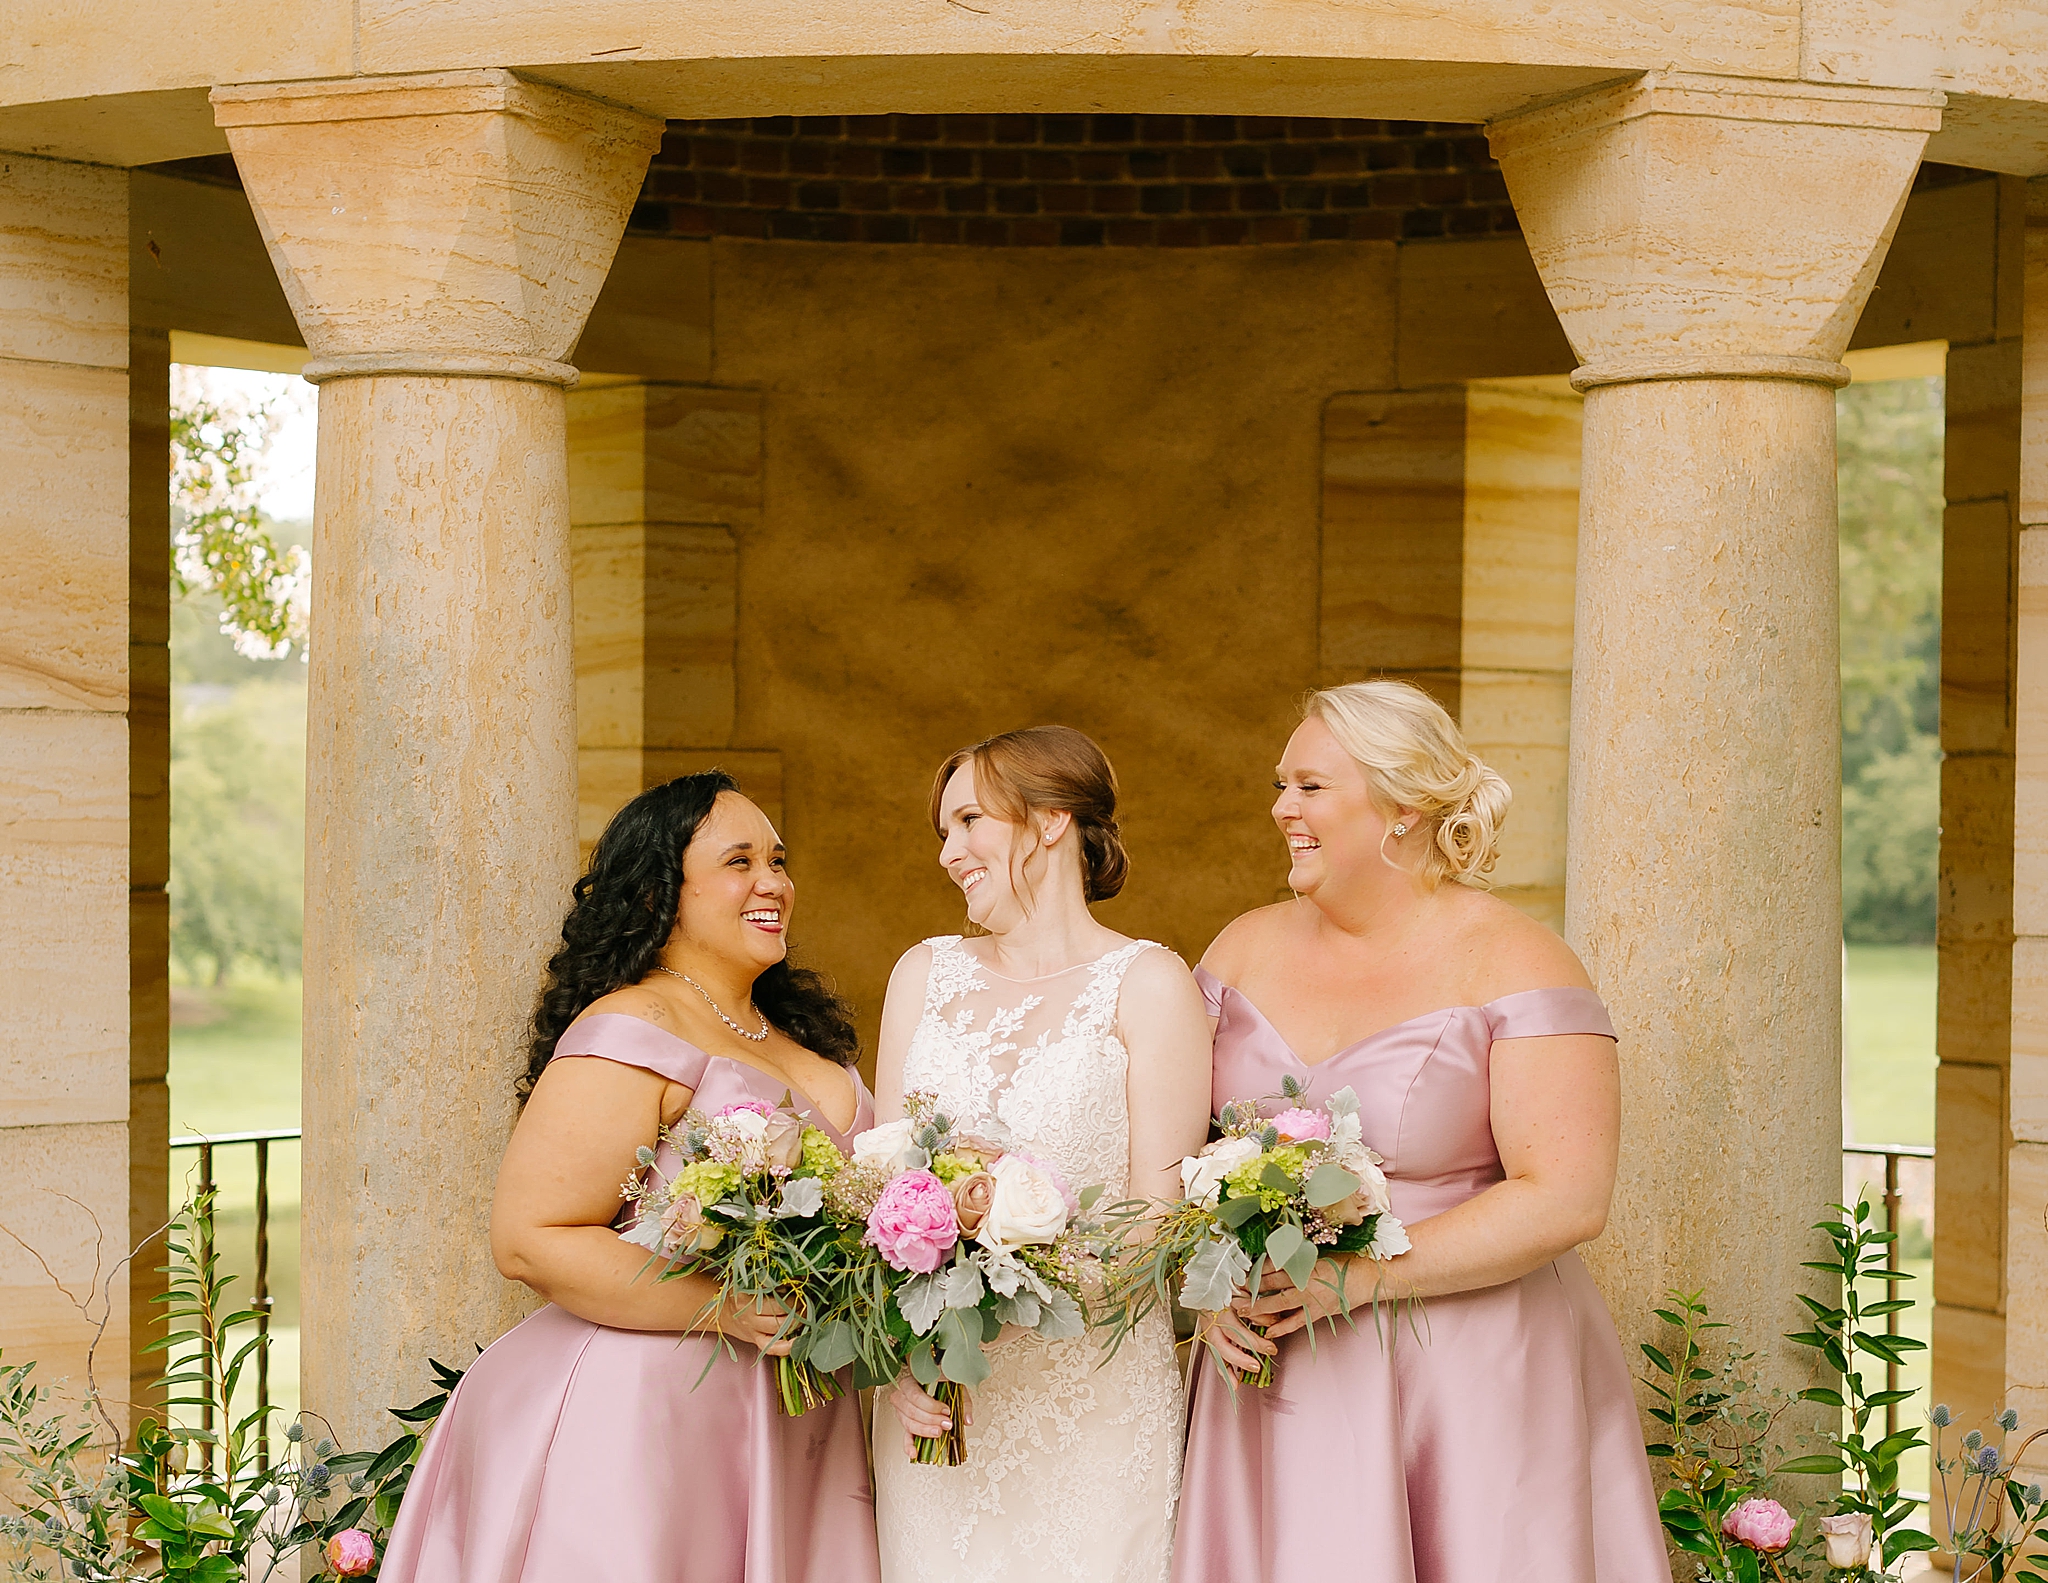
[618,1100,848,1417]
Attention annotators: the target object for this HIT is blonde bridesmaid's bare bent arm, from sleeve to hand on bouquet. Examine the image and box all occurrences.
[1251,1034,1622,1335]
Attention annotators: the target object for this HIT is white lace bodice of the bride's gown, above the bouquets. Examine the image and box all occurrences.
[903,934,1161,1202]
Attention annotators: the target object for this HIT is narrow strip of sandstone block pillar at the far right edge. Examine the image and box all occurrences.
[2003,180,2048,1477]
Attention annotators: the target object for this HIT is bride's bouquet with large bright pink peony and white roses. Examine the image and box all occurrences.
[825,1094,1102,1466]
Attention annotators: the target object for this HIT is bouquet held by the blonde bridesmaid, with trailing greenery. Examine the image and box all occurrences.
[1102,1077,1409,1386]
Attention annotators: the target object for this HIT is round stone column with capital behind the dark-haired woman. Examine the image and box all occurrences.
[213,72,662,1446]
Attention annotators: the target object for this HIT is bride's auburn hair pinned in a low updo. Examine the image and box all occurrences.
[932,725,1130,901]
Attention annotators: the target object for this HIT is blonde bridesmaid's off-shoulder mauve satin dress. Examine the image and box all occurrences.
[1174,969,1671,1583]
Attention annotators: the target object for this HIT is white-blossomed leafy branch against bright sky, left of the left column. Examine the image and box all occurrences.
[170,389,309,659]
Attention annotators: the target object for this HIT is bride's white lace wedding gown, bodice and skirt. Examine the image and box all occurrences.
[874,936,1184,1583]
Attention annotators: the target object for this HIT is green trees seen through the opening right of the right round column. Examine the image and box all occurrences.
[1835,379,1944,942]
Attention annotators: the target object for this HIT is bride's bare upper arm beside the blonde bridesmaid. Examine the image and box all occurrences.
[1122,950,1214,1202]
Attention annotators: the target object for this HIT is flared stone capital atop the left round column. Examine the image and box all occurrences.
[213,70,662,385]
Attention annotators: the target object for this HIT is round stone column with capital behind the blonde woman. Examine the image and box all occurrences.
[1491,74,1939,1408]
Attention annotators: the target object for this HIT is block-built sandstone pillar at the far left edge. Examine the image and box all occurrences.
[0,154,137,1419]
